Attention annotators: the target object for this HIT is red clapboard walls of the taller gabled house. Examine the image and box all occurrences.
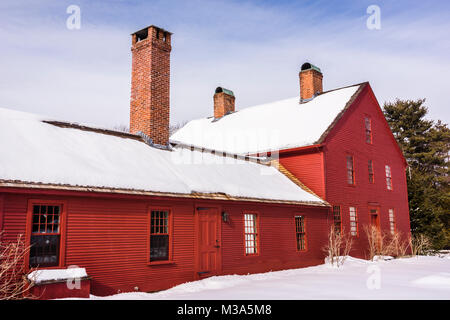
[280,85,410,257]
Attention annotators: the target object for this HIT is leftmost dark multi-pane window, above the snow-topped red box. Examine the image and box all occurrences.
[29,204,61,268]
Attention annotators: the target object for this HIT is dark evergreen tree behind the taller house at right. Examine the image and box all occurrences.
[383,99,450,249]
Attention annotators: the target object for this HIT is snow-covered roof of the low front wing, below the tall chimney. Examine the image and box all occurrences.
[0,108,325,205]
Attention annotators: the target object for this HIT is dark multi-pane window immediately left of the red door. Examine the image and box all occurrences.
[150,210,170,261]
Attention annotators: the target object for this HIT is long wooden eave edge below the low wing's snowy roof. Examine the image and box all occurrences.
[0,180,330,207]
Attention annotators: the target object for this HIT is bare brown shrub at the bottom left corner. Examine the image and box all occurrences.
[0,234,34,300]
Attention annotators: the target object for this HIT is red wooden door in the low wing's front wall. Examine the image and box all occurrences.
[197,208,222,278]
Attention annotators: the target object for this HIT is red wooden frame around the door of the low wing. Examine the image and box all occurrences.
[194,203,222,279]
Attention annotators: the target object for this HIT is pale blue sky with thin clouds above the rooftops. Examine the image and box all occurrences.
[0,0,450,127]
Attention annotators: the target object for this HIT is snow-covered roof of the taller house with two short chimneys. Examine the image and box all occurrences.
[170,84,363,154]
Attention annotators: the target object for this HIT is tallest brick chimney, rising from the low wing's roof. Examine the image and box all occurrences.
[130,25,172,146]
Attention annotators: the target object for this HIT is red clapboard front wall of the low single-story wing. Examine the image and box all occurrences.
[0,190,329,295]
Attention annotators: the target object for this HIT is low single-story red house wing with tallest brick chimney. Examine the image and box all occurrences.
[0,26,334,297]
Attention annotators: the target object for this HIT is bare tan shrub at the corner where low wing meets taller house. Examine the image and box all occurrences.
[323,226,353,267]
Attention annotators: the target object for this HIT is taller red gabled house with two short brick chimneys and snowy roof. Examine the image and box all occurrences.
[171,67,410,257]
